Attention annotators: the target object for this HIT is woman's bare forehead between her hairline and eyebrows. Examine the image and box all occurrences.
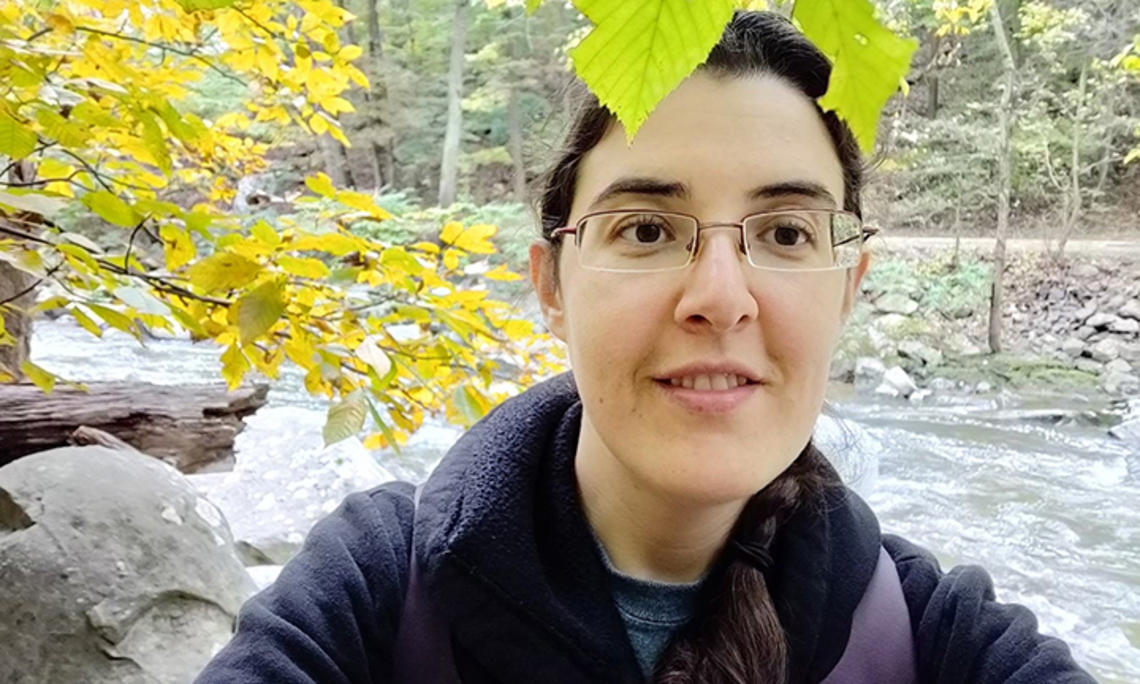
[572,71,844,214]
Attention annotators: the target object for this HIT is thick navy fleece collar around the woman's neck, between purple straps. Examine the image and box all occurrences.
[415,373,879,684]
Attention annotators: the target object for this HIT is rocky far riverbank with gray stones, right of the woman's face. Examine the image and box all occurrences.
[832,242,1140,400]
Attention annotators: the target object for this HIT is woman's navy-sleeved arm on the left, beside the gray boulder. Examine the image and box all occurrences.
[195,482,413,684]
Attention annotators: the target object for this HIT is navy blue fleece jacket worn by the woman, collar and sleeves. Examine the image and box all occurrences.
[196,375,1093,684]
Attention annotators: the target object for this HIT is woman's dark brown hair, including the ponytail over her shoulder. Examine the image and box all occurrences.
[538,11,864,684]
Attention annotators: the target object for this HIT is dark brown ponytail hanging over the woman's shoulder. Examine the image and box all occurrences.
[653,442,839,684]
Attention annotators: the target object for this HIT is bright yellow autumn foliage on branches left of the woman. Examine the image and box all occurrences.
[0,0,561,448]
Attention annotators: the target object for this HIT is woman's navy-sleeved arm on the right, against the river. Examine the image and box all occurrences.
[884,535,1096,684]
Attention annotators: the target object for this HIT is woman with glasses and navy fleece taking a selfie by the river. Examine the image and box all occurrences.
[200,13,1091,684]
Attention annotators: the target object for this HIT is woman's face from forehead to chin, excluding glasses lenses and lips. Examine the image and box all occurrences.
[531,72,866,503]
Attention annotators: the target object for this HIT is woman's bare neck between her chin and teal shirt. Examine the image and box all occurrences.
[575,416,744,583]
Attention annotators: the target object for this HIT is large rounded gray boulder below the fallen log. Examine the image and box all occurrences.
[0,447,254,684]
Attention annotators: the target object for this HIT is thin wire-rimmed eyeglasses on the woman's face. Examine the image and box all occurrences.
[551,209,879,272]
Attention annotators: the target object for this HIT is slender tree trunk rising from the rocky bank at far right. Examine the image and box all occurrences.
[988,3,1016,353]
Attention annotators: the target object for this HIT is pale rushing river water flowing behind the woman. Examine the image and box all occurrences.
[33,321,1140,684]
